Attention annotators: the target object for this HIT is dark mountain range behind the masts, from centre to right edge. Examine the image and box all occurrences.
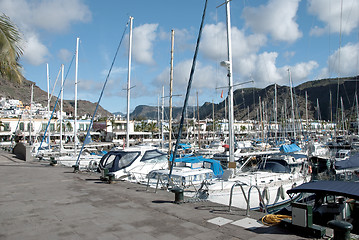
[131,76,359,121]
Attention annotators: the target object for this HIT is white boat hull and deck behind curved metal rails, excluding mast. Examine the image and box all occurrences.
[205,157,310,212]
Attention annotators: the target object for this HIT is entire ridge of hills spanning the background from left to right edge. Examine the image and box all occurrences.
[0,76,359,121]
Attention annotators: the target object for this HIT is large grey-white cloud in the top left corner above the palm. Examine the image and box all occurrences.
[0,0,91,65]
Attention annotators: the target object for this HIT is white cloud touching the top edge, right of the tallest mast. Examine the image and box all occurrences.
[243,0,302,42]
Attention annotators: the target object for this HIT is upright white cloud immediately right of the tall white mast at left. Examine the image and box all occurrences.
[132,24,158,65]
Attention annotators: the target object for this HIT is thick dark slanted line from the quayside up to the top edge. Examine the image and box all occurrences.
[167,0,208,185]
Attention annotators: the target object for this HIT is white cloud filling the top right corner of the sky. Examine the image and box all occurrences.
[308,0,359,35]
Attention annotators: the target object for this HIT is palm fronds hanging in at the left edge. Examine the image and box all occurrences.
[0,14,23,83]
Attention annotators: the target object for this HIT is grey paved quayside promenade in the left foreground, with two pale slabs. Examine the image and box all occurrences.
[0,150,320,240]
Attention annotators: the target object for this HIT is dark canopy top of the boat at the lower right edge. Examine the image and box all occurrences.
[287,181,359,200]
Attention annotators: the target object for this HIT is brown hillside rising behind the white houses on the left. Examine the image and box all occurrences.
[0,77,112,117]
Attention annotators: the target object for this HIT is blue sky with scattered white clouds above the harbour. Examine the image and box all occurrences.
[0,0,359,113]
